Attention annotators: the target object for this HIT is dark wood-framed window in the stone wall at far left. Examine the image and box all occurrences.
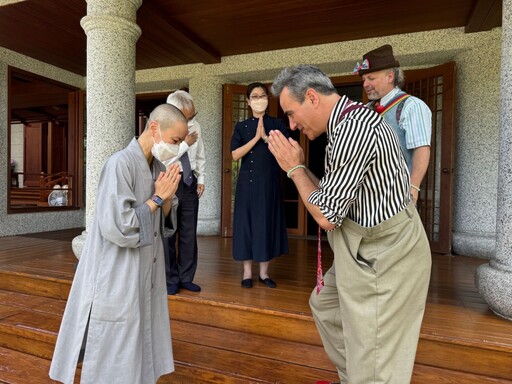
[7,67,84,213]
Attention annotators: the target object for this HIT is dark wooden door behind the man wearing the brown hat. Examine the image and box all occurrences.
[404,62,455,253]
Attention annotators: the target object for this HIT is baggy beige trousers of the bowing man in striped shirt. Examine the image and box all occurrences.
[309,204,432,384]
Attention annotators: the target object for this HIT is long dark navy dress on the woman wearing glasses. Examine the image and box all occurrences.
[231,115,288,262]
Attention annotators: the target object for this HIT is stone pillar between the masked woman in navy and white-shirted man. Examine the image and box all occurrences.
[189,76,226,235]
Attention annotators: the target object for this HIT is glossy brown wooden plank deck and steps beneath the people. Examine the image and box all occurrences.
[0,230,512,384]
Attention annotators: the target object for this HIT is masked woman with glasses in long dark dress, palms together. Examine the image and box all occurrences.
[231,83,288,288]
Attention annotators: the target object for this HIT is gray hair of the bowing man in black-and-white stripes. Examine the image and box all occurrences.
[271,64,337,103]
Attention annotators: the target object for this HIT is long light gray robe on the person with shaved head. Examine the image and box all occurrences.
[50,139,174,384]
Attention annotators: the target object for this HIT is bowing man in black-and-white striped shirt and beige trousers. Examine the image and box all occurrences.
[268,65,431,384]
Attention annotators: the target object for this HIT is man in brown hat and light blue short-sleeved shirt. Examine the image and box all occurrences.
[354,44,432,206]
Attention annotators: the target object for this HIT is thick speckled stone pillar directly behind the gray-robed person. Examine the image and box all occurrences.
[73,0,142,257]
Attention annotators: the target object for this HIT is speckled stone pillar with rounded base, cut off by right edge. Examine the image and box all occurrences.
[475,0,512,320]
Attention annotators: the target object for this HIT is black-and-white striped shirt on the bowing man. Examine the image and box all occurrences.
[308,96,411,228]
